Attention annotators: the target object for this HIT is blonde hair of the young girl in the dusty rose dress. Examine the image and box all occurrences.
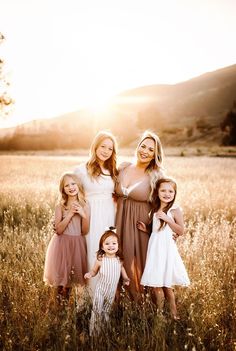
[59,172,86,207]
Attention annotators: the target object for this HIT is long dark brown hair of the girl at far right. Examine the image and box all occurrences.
[150,178,177,229]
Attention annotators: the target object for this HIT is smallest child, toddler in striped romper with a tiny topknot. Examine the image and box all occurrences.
[84,227,130,335]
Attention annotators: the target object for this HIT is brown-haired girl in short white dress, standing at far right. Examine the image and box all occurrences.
[137,178,190,319]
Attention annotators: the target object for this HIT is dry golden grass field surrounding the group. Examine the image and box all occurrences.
[0,155,236,351]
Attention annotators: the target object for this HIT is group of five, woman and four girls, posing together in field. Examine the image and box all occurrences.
[44,131,189,333]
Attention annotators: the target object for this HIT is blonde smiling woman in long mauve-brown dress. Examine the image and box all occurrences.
[115,131,164,300]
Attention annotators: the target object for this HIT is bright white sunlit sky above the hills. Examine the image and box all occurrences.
[0,0,236,128]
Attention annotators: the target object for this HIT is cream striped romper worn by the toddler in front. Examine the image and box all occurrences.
[90,256,121,335]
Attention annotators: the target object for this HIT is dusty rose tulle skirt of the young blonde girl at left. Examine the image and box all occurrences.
[43,234,87,287]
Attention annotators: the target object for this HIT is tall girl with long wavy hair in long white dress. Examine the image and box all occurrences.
[74,131,117,296]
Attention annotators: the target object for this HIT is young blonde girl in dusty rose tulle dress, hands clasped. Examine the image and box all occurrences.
[43,173,89,299]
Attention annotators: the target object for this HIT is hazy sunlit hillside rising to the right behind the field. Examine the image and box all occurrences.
[0,65,236,150]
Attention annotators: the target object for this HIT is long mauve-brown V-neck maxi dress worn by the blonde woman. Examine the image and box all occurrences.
[115,165,151,299]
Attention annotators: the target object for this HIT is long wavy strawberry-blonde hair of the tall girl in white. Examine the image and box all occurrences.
[86,131,118,181]
